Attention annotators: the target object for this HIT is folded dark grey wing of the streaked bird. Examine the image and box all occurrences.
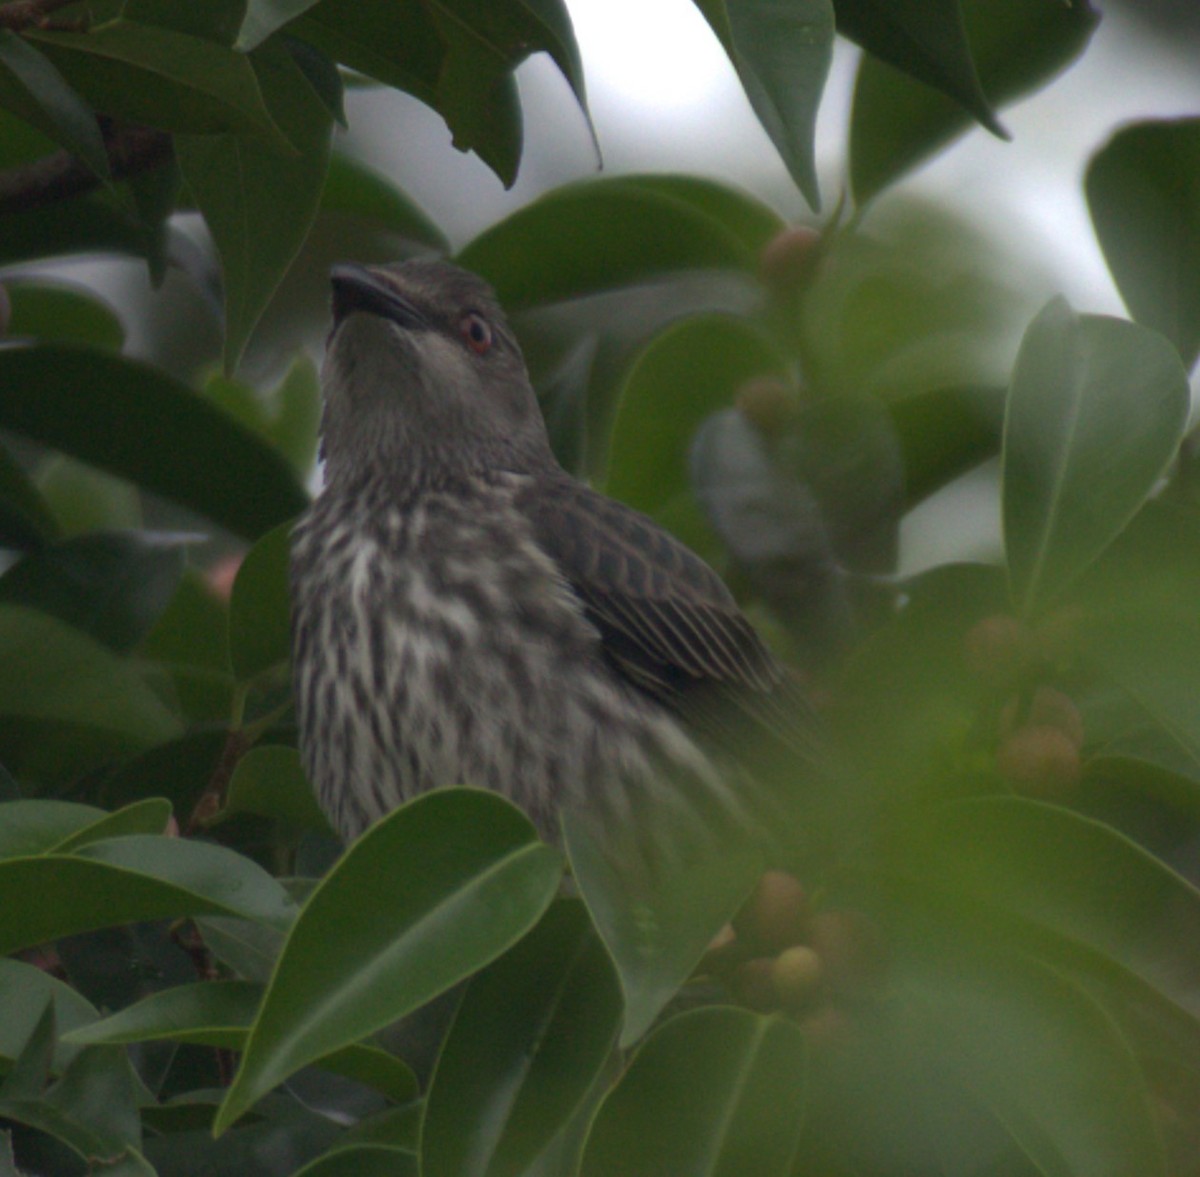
[517,476,808,743]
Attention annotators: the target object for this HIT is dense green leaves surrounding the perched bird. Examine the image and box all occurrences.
[0,0,1200,1177]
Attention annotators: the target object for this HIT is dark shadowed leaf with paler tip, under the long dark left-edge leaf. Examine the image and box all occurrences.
[0,533,184,654]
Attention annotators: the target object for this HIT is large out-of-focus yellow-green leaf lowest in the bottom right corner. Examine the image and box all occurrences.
[894,937,1165,1177]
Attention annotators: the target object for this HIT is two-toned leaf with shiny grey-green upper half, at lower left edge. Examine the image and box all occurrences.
[0,834,294,953]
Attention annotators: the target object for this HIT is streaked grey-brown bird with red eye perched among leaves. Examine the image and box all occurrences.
[290,260,803,840]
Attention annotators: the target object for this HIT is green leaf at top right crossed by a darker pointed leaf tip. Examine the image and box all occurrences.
[850,0,1099,204]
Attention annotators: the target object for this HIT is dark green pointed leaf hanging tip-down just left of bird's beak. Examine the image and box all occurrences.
[175,46,332,372]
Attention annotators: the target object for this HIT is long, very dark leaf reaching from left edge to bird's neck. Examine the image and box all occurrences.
[0,343,307,540]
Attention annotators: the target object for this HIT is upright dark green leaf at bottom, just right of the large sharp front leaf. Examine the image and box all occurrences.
[421,900,622,1177]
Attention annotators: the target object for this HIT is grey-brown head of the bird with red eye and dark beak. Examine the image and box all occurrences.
[322,260,552,479]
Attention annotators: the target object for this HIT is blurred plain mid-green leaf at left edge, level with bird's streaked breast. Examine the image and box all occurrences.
[0,605,179,749]
